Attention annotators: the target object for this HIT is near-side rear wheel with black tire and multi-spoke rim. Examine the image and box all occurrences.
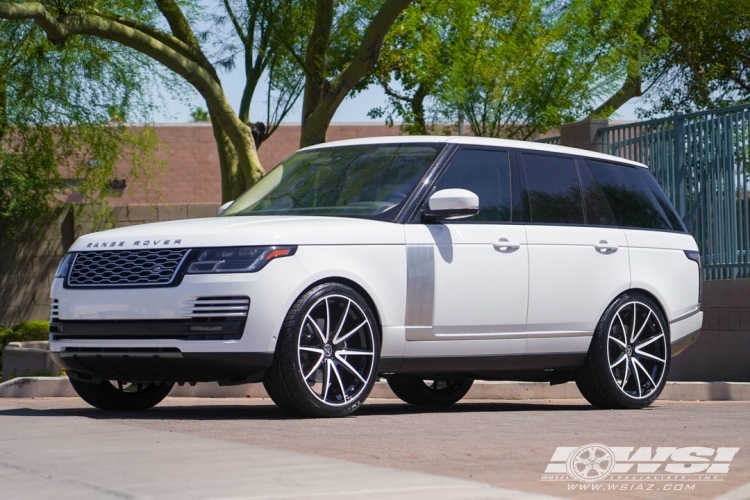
[576,293,671,409]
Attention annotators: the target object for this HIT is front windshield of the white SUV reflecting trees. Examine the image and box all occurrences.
[223,143,443,220]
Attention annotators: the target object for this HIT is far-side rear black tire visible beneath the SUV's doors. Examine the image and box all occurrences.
[388,377,474,407]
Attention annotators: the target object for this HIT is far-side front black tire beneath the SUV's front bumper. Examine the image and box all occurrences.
[70,377,174,411]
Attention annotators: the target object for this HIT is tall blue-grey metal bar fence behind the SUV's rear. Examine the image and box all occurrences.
[599,105,750,279]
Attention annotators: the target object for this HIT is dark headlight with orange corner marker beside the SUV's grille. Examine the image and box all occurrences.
[187,246,297,274]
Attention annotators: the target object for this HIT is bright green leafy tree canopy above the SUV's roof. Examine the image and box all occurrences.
[373,0,646,139]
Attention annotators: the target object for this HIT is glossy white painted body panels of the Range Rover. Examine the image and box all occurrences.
[50,137,703,380]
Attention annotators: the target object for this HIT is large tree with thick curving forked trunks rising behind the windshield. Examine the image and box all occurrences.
[0,0,410,201]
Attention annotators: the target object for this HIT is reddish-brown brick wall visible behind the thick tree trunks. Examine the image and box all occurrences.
[111,123,400,206]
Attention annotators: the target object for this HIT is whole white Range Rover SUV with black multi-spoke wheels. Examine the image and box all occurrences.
[50,137,703,416]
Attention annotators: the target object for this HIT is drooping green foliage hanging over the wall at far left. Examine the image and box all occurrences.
[0,14,156,245]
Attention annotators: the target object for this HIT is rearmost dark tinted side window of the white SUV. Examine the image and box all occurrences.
[588,160,684,231]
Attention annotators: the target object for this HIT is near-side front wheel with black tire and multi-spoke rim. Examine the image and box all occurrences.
[263,283,380,417]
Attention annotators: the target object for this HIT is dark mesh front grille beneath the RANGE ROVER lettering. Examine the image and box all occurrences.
[67,249,189,287]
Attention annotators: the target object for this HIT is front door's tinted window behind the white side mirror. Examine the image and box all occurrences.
[435,149,510,223]
